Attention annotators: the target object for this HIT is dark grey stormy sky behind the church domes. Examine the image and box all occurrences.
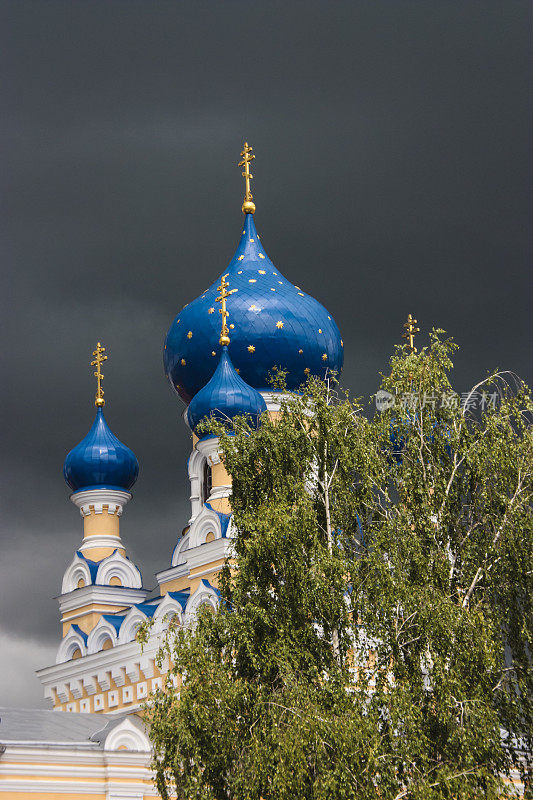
[0,0,533,705]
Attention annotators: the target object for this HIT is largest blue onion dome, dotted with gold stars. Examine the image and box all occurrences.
[164,213,343,403]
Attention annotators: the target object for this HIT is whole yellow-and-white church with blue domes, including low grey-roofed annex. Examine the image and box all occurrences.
[0,143,344,800]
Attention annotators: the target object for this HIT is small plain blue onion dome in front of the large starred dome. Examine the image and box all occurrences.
[186,346,266,431]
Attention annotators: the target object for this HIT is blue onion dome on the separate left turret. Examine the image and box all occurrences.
[63,408,139,492]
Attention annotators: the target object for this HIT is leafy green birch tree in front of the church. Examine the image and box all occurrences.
[143,331,533,800]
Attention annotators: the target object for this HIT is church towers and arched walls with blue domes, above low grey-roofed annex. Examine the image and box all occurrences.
[38,143,343,713]
